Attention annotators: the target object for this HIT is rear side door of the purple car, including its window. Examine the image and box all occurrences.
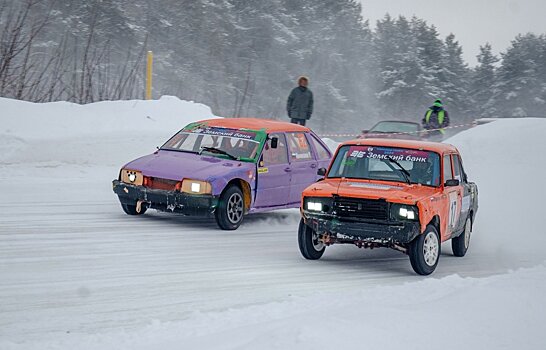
[286,132,318,204]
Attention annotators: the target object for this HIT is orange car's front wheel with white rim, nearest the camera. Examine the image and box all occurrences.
[408,225,442,275]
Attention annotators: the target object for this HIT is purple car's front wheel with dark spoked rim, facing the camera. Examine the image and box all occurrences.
[214,185,245,230]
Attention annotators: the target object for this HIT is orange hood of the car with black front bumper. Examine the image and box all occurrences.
[303,179,438,204]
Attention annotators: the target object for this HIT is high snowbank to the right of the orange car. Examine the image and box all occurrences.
[446,118,546,269]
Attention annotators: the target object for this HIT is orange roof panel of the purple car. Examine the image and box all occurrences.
[201,118,309,132]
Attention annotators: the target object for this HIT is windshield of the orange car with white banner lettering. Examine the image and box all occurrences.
[327,145,440,187]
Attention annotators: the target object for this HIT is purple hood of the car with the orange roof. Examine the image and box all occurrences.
[125,150,256,181]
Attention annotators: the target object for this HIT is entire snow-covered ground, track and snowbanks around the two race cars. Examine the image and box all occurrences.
[0,98,546,350]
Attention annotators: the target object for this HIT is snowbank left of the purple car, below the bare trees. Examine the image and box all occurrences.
[0,96,215,168]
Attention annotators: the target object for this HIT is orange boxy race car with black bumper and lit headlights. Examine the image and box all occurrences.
[298,139,478,275]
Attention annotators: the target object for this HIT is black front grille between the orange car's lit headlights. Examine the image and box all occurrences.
[333,197,389,220]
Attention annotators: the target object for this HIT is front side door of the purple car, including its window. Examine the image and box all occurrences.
[254,133,291,208]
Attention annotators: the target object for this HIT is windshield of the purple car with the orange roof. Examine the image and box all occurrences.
[161,128,260,160]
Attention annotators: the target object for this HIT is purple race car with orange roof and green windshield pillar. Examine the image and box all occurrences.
[113,118,332,230]
